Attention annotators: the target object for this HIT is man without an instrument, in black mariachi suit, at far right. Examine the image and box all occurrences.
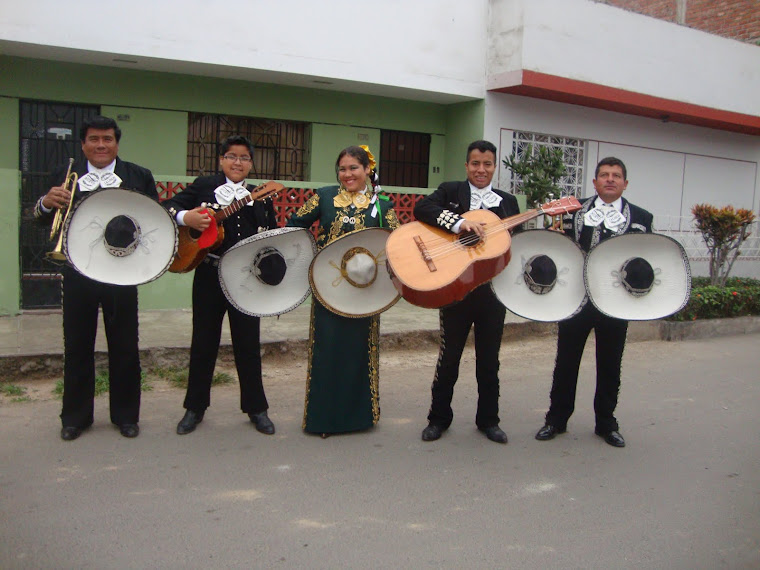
[536,157,652,447]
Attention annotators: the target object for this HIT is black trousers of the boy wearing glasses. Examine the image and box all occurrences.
[184,262,269,414]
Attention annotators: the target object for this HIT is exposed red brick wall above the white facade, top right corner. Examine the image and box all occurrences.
[597,0,760,43]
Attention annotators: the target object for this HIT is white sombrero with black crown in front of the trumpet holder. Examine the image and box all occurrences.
[63,188,178,285]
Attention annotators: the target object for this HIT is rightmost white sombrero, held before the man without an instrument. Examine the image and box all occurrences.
[584,234,691,321]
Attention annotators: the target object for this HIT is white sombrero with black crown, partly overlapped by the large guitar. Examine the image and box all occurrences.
[491,230,586,322]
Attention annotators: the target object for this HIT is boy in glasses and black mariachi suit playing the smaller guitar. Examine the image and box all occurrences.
[163,136,285,435]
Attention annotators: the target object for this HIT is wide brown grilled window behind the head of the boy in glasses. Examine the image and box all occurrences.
[187,113,309,180]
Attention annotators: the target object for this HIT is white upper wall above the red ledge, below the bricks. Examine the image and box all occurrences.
[486,0,760,116]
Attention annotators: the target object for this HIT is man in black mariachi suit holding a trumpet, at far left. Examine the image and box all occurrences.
[34,116,158,441]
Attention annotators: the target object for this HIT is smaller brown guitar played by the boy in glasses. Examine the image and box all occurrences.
[169,181,285,273]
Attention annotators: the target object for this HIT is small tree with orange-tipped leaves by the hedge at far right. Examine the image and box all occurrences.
[691,204,755,287]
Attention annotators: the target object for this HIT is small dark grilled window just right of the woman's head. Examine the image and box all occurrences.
[379,131,430,188]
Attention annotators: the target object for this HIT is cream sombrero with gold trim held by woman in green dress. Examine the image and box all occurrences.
[309,228,401,318]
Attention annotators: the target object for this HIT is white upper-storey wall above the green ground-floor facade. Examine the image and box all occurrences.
[0,0,488,98]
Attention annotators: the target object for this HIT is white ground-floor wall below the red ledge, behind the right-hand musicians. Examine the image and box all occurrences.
[484,93,760,277]
